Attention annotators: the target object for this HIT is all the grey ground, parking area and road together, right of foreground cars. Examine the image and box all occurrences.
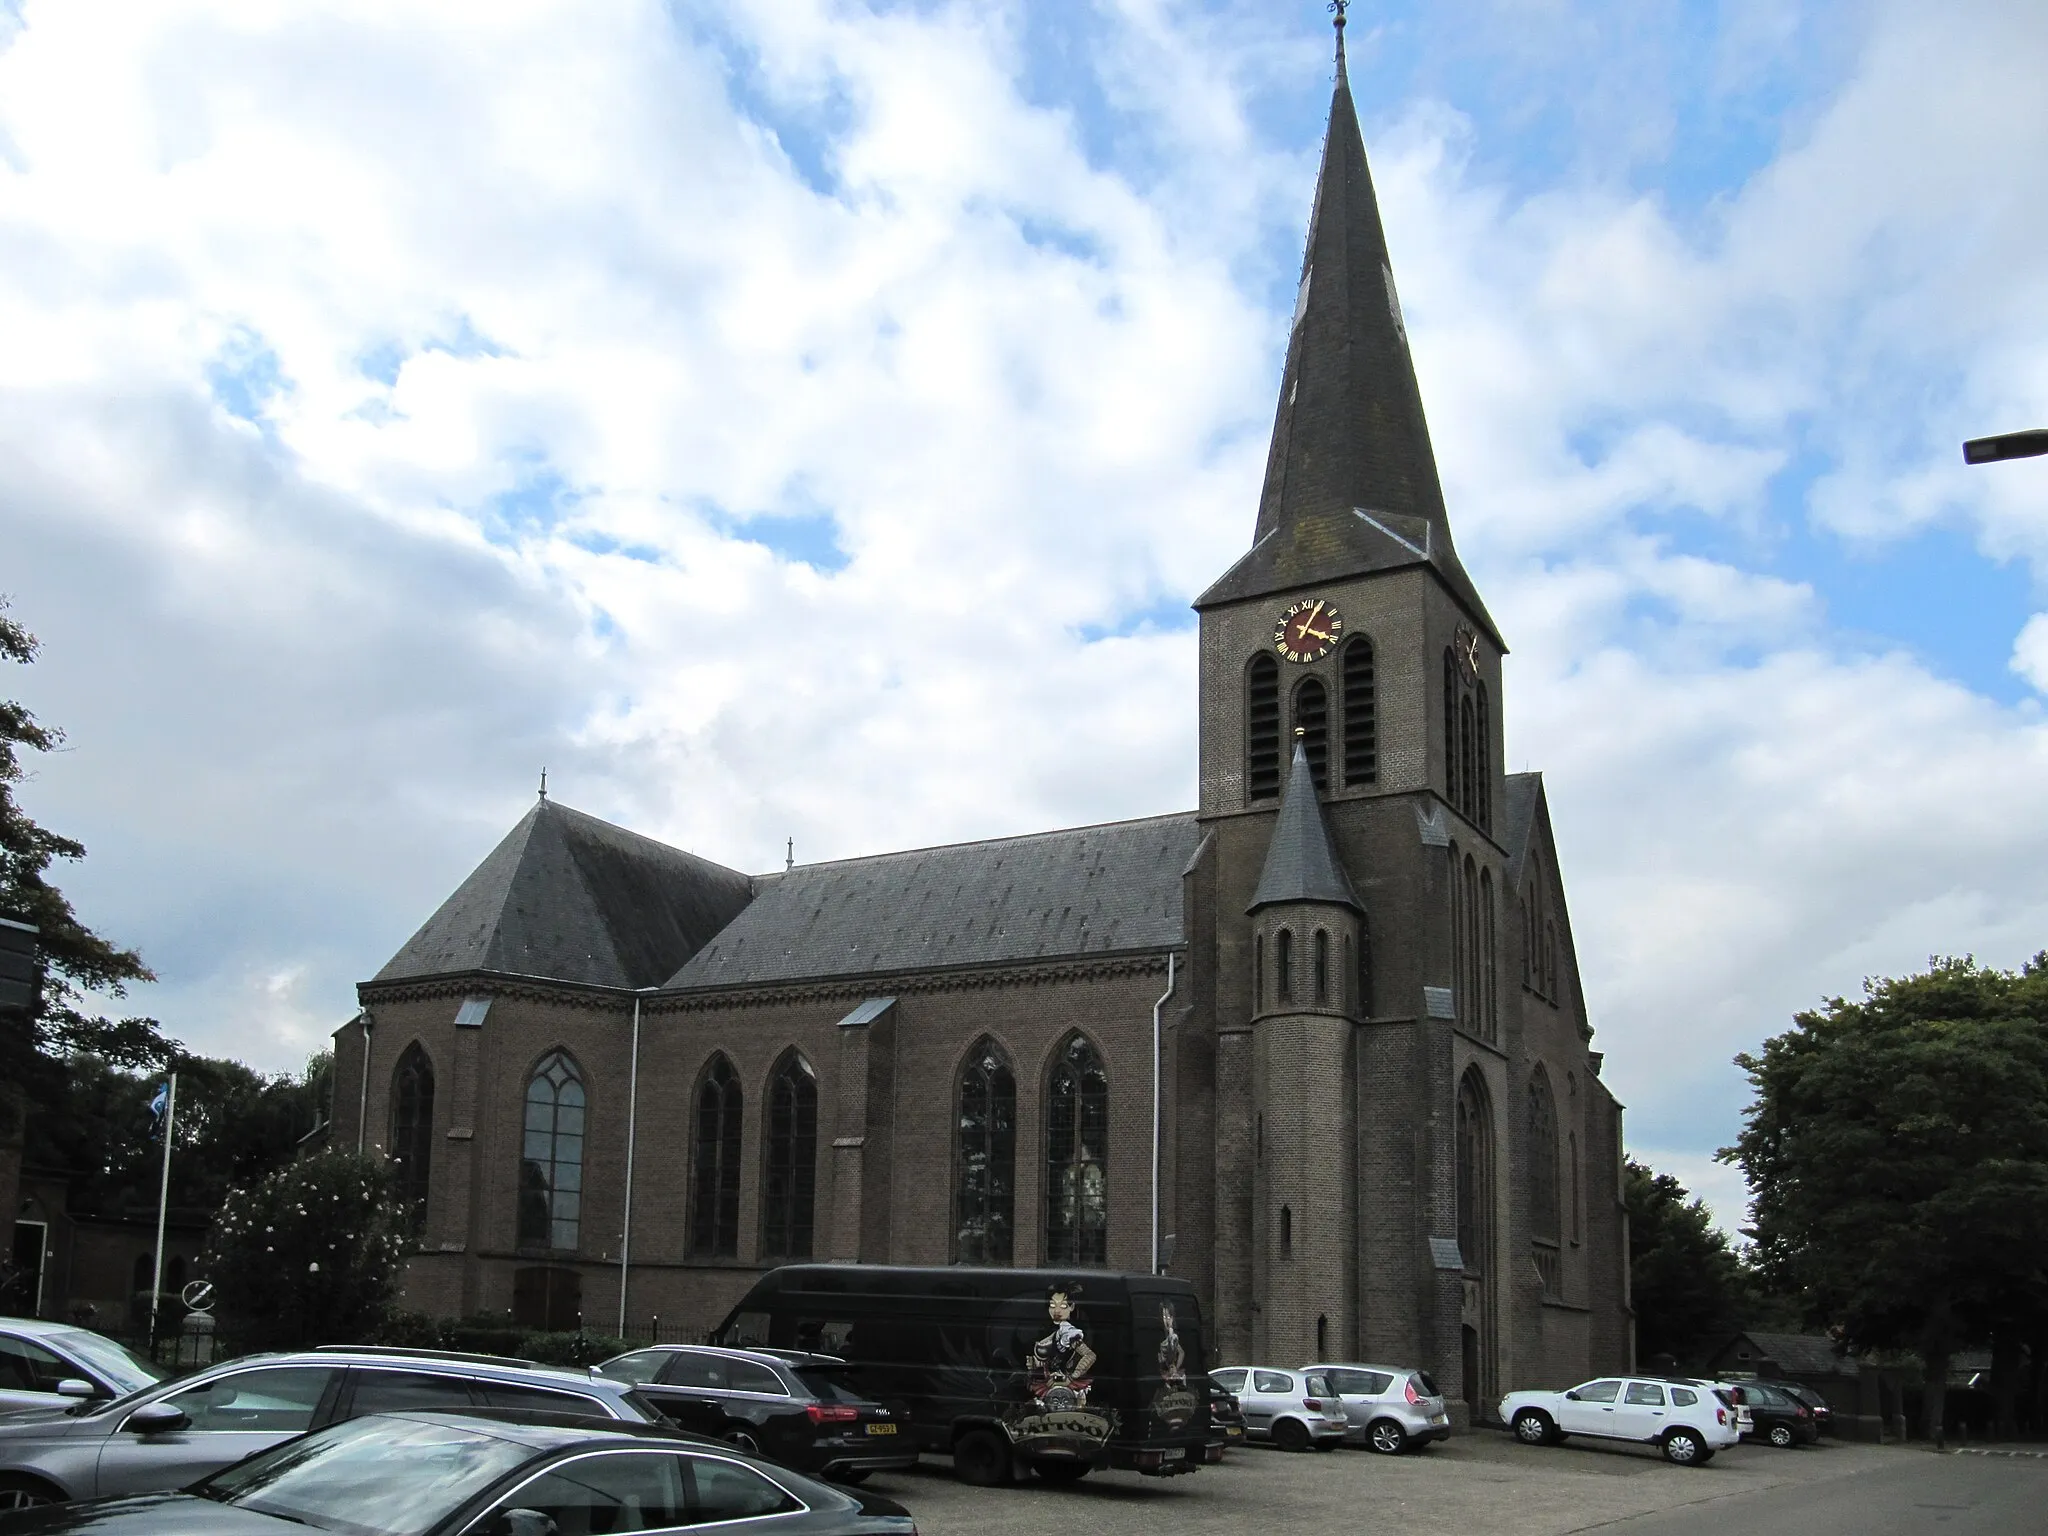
[847,1432,2048,1536]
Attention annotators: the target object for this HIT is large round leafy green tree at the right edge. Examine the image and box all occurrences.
[1722,954,2048,1438]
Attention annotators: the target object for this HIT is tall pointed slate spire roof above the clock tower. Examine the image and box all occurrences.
[1194,48,1505,649]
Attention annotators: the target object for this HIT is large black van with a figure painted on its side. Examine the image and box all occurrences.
[711,1264,1208,1485]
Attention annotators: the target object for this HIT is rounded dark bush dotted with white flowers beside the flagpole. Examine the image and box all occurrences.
[203,1151,410,1348]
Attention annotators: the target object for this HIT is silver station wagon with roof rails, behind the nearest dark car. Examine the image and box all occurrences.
[0,1348,662,1509]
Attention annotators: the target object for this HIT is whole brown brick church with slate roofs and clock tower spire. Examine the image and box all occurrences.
[336,33,1632,1411]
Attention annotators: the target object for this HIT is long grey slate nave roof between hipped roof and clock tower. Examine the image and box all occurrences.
[668,811,1200,989]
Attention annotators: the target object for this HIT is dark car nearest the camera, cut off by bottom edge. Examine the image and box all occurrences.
[0,1413,918,1536]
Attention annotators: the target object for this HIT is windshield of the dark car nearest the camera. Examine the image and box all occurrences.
[193,1415,535,1536]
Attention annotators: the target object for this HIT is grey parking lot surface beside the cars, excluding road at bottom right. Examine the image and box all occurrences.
[866,1432,1957,1536]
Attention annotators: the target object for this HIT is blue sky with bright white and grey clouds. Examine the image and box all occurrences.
[0,0,2048,1229]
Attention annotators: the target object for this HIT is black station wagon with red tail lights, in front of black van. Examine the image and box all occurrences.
[598,1343,918,1483]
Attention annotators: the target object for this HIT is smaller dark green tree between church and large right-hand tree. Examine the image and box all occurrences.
[1622,1157,1757,1362]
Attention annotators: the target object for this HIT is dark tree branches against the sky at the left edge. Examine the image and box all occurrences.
[0,598,178,1102]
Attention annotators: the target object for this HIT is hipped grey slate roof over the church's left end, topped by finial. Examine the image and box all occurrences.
[375,801,754,987]
